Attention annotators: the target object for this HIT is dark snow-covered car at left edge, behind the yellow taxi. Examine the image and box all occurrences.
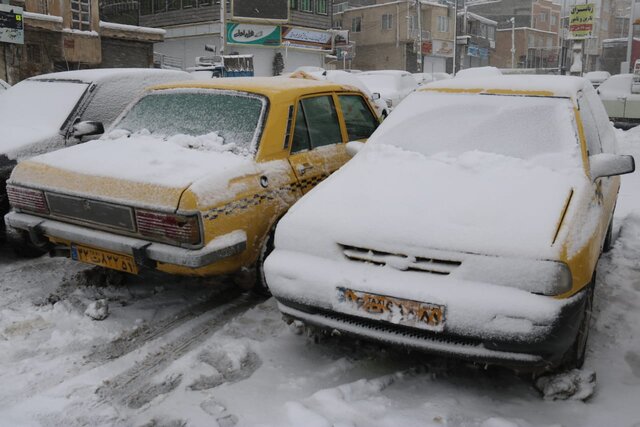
[0,68,192,239]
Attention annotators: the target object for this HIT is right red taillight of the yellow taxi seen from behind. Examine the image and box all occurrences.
[136,210,200,245]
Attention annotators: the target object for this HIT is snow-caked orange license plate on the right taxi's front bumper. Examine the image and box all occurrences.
[338,288,445,332]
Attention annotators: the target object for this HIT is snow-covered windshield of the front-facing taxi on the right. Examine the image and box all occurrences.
[369,92,580,168]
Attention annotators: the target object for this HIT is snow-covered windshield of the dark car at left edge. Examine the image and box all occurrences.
[0,80,89,130]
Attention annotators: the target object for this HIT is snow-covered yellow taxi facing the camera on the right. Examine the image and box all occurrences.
[265,76,635,370]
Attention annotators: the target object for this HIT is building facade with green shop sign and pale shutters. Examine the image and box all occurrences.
[139,0,336,76]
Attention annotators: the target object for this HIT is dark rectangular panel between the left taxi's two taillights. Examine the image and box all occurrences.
[47,193,135,232]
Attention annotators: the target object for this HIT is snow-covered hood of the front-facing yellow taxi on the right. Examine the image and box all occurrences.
[276,144,584,259]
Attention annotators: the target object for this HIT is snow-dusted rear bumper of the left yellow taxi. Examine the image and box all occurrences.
[5,212,247,268]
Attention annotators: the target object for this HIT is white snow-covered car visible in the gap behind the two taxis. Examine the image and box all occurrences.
[358,70,418,111]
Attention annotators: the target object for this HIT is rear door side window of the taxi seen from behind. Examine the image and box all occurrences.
[291,95,342,153]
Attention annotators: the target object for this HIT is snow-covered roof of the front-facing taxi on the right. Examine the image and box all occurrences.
[418,75,591,99]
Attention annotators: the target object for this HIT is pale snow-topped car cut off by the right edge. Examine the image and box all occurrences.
[598,74,640,128]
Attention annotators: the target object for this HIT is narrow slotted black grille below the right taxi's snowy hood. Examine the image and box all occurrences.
[341,245,462,276]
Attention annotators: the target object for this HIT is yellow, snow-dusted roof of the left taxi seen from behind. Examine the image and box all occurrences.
[151,77,354,98]
